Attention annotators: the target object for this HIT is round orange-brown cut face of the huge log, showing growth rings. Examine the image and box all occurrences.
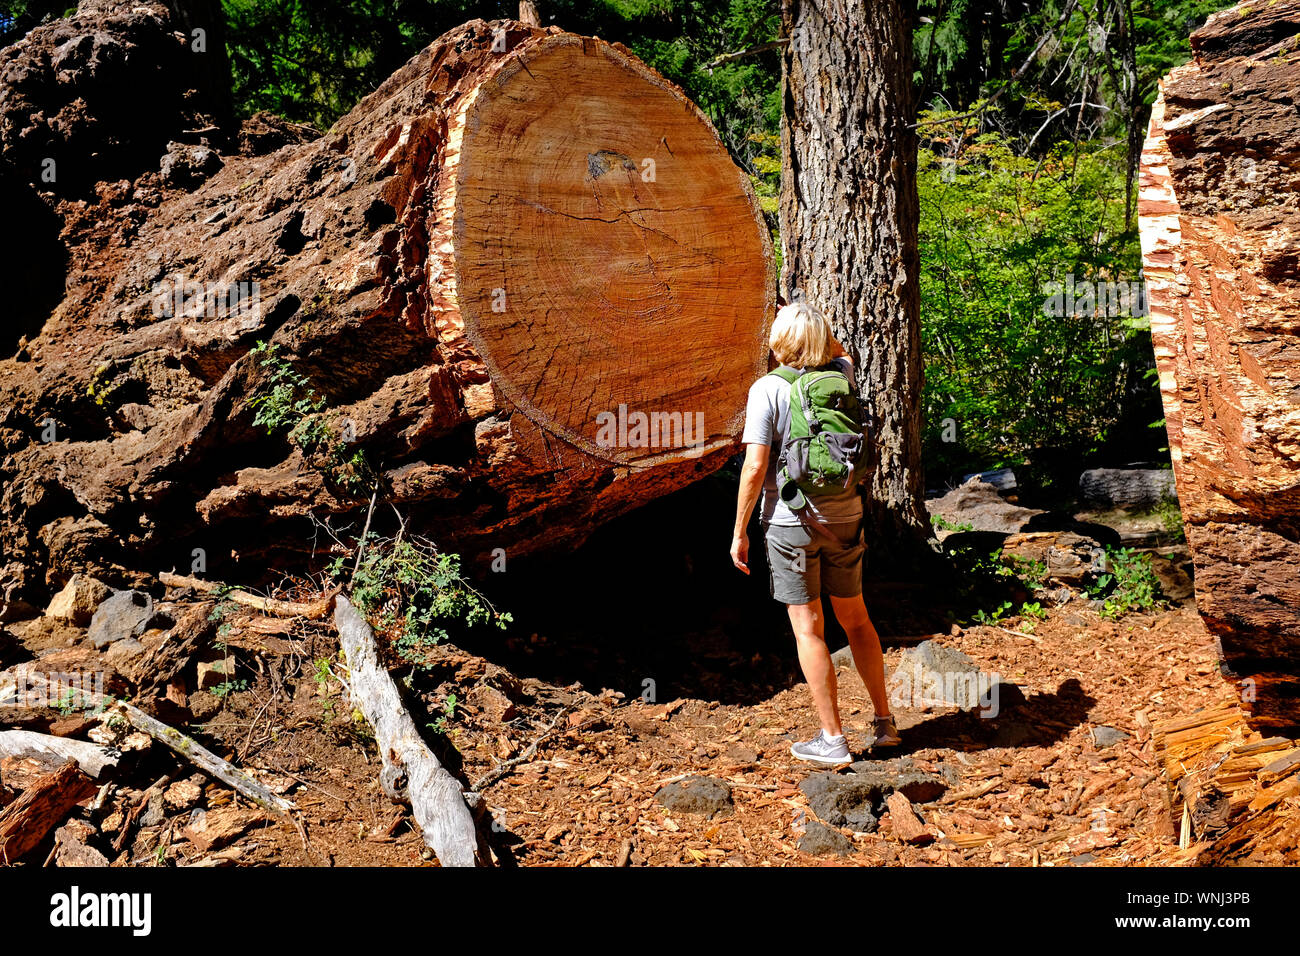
[430,34,770,464]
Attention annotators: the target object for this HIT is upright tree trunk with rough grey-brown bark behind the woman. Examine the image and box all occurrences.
[780,0,928,555]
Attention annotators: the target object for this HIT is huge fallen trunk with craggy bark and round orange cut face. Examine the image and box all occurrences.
[0,11,776,604]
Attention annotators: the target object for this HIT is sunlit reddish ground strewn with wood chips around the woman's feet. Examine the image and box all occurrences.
[195,605,1216,866]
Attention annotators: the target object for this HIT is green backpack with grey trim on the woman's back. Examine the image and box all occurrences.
[770,365,871,511]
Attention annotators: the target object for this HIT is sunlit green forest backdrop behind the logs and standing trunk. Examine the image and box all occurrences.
[0,0,1227,492]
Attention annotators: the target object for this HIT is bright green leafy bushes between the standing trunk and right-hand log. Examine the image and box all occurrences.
[918,114,1153,486]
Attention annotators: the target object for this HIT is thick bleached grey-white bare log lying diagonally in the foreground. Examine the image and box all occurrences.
[334,596,485,866]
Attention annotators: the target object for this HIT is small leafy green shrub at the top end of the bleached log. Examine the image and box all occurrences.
[330,533,511,669]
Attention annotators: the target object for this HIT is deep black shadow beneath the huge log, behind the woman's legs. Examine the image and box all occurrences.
[458,472,948,705]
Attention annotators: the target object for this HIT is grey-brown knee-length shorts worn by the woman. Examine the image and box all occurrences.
[763,519,866,604]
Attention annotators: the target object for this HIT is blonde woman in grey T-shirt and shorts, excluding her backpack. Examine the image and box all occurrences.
[731,302,898,763]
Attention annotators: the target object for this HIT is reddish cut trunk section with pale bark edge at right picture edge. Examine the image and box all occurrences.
[1139,0,1300,731]
